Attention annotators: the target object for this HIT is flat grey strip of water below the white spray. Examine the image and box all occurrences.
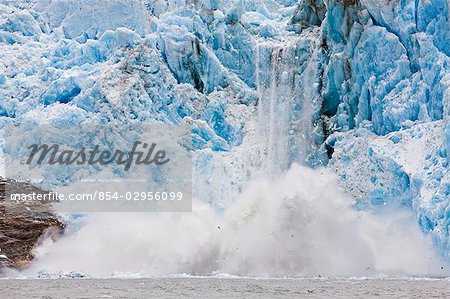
[0,278,450,299]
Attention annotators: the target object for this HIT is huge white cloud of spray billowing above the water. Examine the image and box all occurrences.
[27,164,443,277]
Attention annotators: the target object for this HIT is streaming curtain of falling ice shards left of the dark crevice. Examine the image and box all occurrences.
[256,38,320,175]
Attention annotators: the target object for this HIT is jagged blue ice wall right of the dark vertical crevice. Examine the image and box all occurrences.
[316,1,450,258]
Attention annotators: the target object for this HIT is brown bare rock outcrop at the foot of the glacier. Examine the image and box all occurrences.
[0,178,64,270]
